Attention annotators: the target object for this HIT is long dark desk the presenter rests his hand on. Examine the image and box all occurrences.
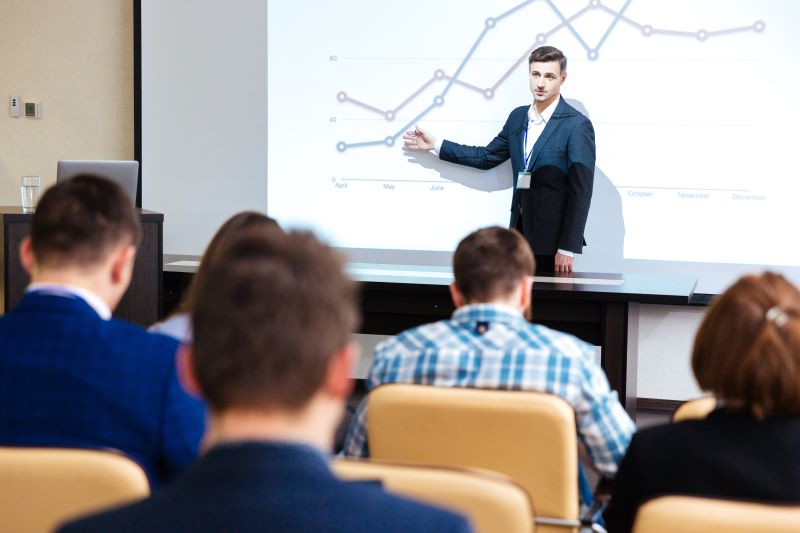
[164,255,696,415]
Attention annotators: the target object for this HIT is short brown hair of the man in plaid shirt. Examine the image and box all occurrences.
[453,226,536,303]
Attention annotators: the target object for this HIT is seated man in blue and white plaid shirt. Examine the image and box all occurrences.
[344,227,635,477]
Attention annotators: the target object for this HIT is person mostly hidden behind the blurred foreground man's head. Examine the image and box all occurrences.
[150,211,278,342]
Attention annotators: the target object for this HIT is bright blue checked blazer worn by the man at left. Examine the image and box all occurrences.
[0,292,205,484]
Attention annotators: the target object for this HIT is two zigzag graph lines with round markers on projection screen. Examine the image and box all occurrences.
[336,0,766,152]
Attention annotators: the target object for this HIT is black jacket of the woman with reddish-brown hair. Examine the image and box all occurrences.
[605,410,800,533]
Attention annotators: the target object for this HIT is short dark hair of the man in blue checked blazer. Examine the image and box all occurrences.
[31,175,141,268]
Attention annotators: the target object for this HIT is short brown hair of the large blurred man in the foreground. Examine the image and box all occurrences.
[192,227,358,412]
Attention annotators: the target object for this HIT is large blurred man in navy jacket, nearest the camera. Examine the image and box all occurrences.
[62,227,469,533]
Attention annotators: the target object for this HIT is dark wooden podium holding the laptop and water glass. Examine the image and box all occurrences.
[0,207,164,326]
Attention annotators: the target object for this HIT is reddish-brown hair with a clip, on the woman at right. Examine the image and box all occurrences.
[692,272,800,418]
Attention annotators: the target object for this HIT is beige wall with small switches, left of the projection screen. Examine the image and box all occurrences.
[0,0,134,205]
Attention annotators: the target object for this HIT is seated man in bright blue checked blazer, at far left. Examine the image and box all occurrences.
[0,176,205,484]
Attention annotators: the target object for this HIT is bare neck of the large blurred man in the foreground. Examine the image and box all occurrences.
[202,398,342,451]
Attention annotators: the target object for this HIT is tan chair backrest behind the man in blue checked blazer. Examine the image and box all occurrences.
[0,447,150,533]
